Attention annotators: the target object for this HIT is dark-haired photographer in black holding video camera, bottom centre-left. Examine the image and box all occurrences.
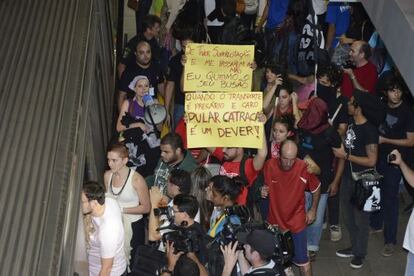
[163,194,207,275]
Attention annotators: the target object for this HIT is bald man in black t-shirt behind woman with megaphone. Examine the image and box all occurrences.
[118,41,164,110]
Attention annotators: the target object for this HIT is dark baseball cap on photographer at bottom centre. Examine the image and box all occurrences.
[237,230,276,258]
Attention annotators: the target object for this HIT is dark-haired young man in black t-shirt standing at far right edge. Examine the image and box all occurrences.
[371,76,414,257]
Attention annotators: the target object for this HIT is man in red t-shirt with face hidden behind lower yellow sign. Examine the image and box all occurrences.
[212,132,267,205]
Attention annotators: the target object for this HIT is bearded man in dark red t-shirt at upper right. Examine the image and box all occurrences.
[342,40,378,99]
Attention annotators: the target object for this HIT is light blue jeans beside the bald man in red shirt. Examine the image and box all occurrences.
[305,192,328,251]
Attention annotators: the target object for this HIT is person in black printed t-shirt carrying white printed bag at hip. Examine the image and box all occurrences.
[333,90,381,269]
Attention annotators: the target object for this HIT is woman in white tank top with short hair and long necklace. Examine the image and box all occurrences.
[104,144,150,264]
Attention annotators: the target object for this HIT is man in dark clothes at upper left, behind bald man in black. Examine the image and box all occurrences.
[118,15,161,78]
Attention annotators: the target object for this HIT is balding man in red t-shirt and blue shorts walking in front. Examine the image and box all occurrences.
[262,140,320,275]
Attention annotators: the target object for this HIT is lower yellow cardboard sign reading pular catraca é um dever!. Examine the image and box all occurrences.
[185,92,264,148]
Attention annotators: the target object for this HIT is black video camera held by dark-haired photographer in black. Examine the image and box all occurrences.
[162,225,200,254]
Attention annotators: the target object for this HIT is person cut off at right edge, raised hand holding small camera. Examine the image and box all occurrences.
[391,150,414,276]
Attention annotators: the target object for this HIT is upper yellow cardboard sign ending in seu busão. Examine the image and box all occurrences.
[184,43,254,92]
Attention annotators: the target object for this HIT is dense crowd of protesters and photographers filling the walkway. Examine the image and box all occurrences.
[78,0,414,276]
